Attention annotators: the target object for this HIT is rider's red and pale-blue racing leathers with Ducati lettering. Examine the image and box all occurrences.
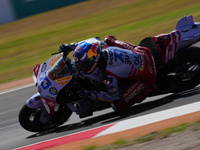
[66,36,156,111]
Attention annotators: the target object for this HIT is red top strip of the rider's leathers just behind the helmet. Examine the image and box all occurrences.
[104,35,136,50]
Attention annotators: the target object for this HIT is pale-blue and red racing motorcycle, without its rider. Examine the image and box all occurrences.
[19,16,200,132]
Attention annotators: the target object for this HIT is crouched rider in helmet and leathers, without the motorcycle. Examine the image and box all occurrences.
[59,36,156,111]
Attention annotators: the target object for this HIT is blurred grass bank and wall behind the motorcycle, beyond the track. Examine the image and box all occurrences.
[0,0,200,84]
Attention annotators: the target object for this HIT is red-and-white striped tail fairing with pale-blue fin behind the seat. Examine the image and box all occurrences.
[152,16,200,65]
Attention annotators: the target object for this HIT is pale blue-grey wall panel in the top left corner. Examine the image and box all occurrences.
[0,0,16,24]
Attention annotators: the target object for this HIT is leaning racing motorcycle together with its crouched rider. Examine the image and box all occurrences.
[18,16,200,132]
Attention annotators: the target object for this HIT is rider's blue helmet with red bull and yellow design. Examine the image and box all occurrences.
[73,38,101,74]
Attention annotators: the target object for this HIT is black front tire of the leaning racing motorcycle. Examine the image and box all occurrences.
[18,104,72,132]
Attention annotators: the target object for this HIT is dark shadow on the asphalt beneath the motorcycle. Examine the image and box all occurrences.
[27,87,200,139]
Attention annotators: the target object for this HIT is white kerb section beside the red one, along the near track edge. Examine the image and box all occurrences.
[93,102,200,138]
